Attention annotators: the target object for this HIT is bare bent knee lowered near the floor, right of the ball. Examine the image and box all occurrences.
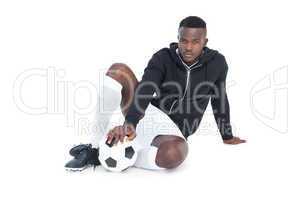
[155,139,188,169]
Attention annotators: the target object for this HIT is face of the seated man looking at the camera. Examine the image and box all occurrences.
[178,27,207,64]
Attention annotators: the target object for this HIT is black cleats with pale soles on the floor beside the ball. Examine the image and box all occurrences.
[65,144,101,171]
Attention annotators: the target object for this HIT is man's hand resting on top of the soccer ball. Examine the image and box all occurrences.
[106,123,136,145]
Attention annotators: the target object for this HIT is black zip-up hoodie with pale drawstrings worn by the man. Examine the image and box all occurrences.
[125,43,233,140]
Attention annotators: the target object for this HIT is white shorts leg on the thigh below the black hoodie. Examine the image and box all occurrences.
[136,103,185,147]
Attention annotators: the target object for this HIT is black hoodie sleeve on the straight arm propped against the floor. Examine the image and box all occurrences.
[211,56,233,140]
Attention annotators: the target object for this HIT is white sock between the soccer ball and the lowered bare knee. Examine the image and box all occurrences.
[134,146,164,170]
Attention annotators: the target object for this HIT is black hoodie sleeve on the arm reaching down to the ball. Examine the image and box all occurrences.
[125,54,165,128]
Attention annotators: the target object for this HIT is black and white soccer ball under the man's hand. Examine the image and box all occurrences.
[99,137,138,172]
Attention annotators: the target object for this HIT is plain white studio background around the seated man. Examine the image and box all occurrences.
[0,0,300,200]
